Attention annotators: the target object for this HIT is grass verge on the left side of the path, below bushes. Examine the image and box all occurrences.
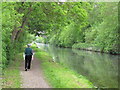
[2,53,23,88]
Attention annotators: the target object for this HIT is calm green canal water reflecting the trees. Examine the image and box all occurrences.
[37,43,119,88]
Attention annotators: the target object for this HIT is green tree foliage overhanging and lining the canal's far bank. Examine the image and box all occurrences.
[29,2,119,53]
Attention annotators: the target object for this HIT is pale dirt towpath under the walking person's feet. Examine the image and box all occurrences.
[20,58,50,88]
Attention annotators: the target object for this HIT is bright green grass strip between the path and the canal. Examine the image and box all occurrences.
[33,47,94,88]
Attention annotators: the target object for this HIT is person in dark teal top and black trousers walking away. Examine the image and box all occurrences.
[25,44,33,71]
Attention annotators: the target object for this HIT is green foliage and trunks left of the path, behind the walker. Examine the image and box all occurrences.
[2,2,34,68]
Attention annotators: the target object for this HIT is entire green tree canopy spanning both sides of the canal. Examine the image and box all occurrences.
[2,2,119,66]
